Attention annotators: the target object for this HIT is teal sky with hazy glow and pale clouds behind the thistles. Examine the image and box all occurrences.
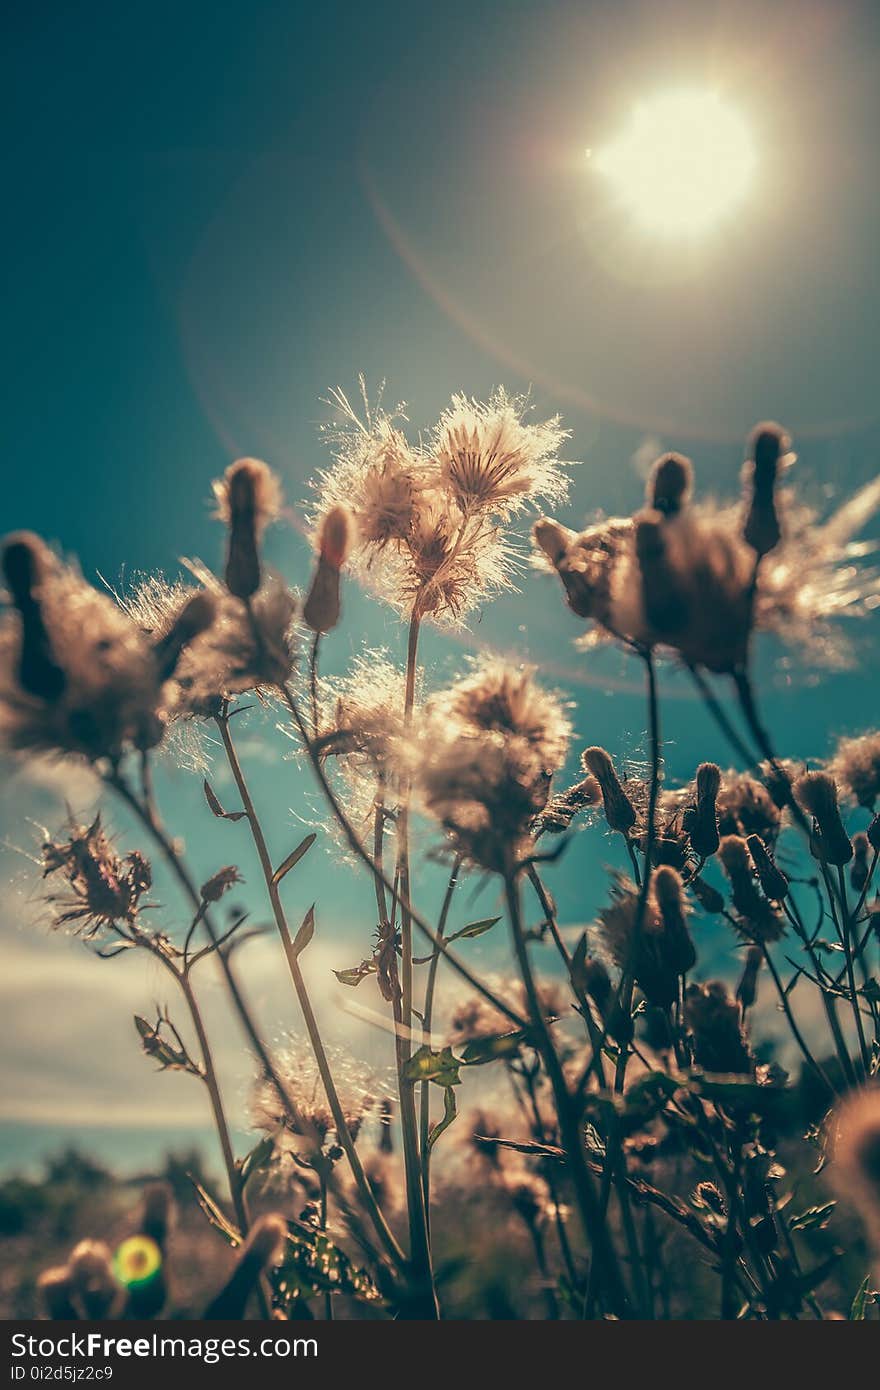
[0,0,880,1166]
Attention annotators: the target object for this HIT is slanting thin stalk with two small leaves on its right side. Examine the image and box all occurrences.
[215,716,403,1265]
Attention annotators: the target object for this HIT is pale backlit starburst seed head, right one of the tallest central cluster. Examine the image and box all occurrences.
[428,391,569,517]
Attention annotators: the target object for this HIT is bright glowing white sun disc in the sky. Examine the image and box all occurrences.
[594,89,755,236]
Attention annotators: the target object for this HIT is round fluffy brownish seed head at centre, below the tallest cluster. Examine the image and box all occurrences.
[410,657,570,872]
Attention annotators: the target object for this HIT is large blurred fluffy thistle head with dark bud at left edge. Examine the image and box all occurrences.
[0,532,169,762]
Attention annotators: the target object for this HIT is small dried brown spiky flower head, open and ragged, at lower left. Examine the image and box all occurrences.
[43,815,152,941]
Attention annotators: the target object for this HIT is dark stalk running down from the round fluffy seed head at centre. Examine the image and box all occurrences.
[505,863,631,1318]
